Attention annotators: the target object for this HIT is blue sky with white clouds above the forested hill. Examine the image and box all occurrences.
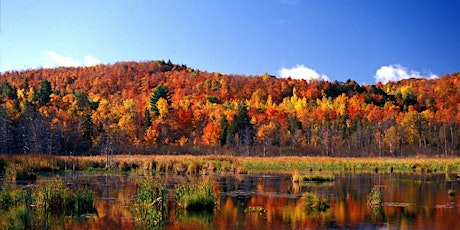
[0,0,460,84]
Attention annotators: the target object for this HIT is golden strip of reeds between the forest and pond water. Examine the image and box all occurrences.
[0,154,460,175]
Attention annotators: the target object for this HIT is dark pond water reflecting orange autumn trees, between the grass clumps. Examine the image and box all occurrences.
[0,172,460,229]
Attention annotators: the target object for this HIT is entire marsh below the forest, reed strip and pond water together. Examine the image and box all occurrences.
[0,155,460,229]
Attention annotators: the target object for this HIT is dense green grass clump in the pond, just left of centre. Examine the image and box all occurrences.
[174,181,216,212]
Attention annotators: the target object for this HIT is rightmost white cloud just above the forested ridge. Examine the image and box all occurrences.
[374,64,438,83]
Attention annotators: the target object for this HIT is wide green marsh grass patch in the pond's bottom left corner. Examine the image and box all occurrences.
[0,177,96,229]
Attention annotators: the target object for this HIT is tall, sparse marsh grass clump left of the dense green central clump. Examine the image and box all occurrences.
[133,178,168,228]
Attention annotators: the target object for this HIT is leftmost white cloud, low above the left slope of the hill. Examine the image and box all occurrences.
[43,51,101,68]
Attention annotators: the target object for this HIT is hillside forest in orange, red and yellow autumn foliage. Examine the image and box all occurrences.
[0,61,460,157]
